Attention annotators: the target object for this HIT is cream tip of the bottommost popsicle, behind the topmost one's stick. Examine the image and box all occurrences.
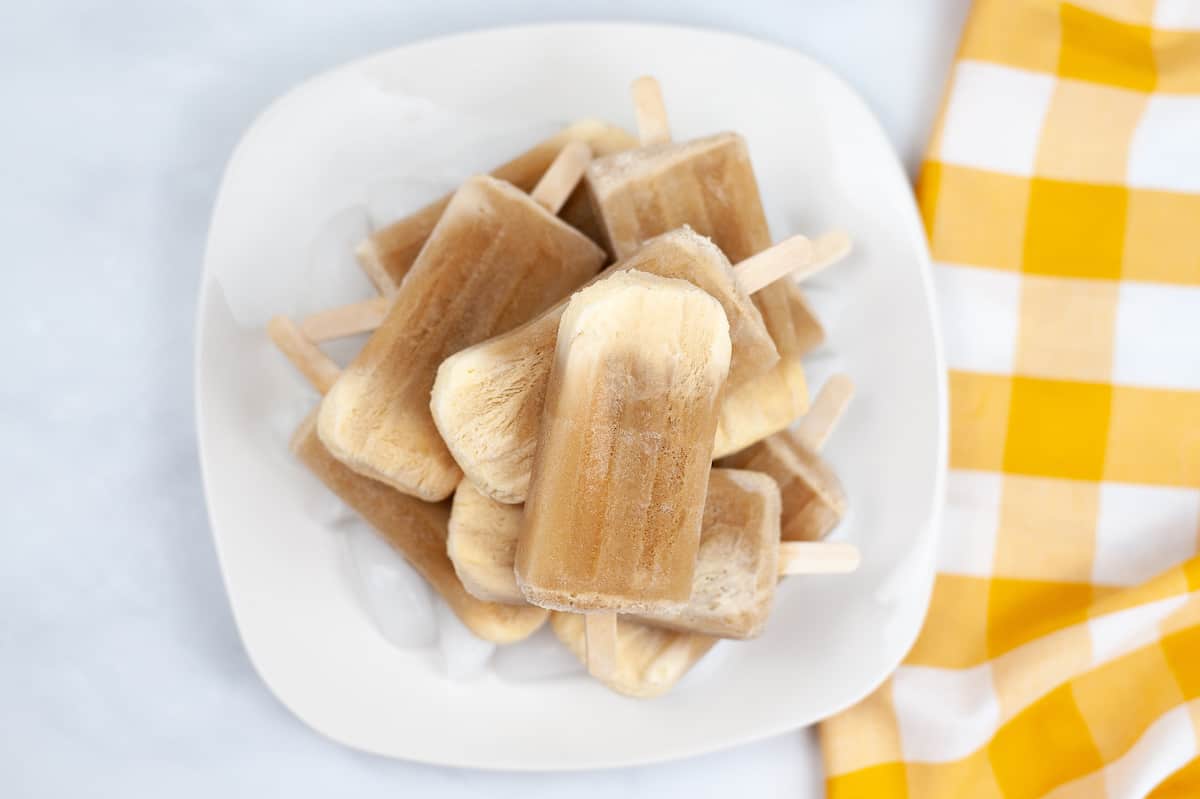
[550,613,718,699]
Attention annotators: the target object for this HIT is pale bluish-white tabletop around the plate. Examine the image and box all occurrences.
[0,0,967,798]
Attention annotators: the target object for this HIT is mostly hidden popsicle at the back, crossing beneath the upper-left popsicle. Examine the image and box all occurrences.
[356,120,637,294]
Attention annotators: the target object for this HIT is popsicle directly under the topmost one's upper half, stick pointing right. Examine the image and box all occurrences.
[431,221,812,503]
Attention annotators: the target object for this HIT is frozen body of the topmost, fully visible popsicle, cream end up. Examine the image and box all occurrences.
[516,270,730,613]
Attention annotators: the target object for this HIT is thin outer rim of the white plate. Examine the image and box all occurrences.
[192,20,949,773]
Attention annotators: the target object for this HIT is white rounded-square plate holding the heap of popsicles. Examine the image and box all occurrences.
[196,24,946,769]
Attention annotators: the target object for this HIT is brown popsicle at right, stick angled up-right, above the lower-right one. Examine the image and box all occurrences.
[719,374,854,541]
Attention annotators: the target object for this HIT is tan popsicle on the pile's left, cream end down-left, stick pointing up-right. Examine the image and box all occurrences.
[317,144,605,501]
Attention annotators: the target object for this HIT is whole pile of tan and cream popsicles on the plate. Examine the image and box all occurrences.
[269,78,858,696]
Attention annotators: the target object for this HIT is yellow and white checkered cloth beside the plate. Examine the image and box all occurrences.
[821,0,1200,799]
